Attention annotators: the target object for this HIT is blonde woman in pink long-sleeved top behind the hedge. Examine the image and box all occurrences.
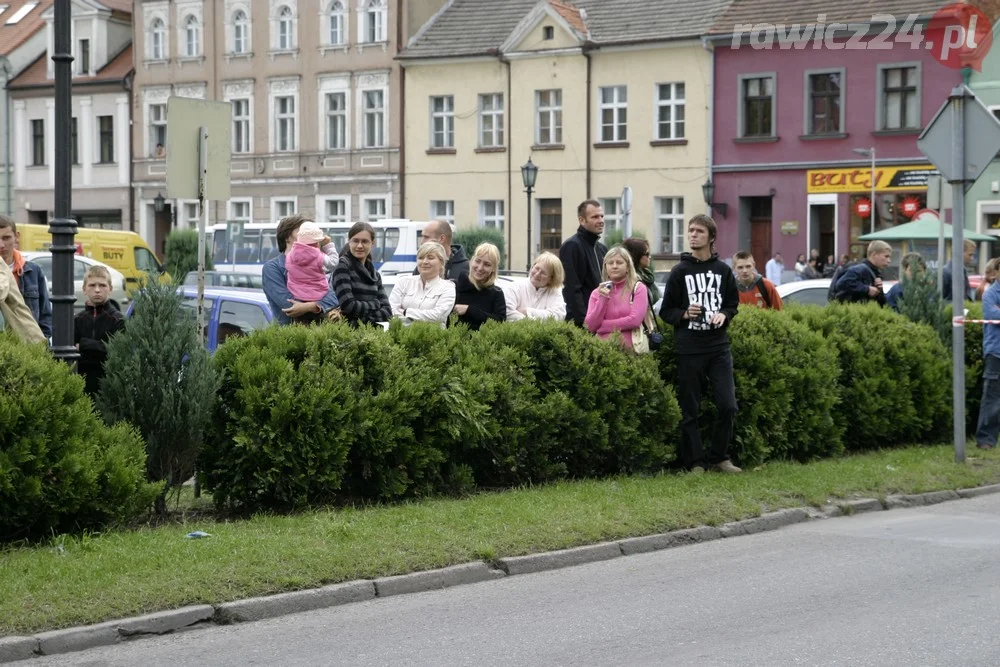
[583,246,649,350]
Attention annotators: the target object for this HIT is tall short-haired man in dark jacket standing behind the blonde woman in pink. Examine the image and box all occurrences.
[559,199,608,327]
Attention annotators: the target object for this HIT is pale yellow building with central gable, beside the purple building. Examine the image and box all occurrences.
[400,0,728,270]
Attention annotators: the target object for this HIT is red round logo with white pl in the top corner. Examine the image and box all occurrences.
[924,3,993,72]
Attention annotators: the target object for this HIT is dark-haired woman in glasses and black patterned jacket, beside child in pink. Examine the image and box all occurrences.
[333,222,392,327]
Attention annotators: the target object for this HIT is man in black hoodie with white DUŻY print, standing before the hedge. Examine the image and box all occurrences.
[660,215,742,473]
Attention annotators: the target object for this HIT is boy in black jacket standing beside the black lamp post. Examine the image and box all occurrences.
[73,266,125,396]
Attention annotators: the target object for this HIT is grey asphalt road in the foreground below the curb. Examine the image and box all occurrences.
[29,495,1000,667]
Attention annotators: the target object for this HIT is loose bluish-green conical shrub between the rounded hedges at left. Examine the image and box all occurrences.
[97,280,218,511]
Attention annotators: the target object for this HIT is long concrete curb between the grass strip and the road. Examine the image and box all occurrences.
[0,484,1000,663]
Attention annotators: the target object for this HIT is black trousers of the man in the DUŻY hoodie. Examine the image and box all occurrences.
[677,349,737,468]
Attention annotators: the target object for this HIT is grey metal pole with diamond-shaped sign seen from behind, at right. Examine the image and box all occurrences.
[917,85,1000,463]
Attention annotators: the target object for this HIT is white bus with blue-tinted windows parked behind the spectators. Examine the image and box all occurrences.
[206,219,427,274]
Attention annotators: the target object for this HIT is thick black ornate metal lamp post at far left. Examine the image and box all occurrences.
[49,0,80,364]
